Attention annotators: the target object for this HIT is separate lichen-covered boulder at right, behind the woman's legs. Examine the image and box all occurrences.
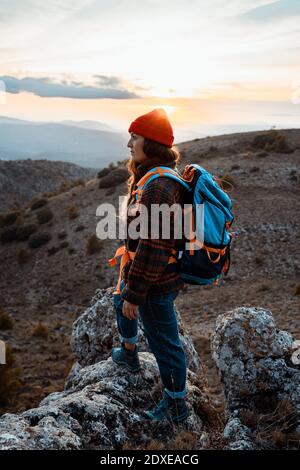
[212,307,300,449]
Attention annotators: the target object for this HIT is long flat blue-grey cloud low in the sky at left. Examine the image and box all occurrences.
[0,75,141,99]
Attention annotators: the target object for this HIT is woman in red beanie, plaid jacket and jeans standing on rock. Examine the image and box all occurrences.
[112,109,189,423]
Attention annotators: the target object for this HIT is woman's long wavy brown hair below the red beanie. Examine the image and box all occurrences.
[126,137,180,205]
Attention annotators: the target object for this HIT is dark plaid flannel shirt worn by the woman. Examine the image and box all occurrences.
[121,173,185,305]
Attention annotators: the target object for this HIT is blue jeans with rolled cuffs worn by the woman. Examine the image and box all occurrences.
[114,280,187,398]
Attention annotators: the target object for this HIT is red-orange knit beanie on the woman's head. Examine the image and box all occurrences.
[128,108,174,147]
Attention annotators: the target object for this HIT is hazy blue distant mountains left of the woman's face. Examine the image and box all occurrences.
[0,116,129,168]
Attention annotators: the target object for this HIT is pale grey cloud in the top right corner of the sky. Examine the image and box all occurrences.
[240,0,300,22]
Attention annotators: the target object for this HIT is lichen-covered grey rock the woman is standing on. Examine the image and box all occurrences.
[0,288,214,449]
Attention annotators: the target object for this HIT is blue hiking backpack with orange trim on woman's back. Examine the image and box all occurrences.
[135,164,234,285]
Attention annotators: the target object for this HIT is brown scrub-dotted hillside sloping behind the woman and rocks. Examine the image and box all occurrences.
[0,129,300,418]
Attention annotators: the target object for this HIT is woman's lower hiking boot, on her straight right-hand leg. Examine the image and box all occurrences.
[145,393,190,424]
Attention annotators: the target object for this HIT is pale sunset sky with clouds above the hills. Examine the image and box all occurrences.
[0,0,300,142]
